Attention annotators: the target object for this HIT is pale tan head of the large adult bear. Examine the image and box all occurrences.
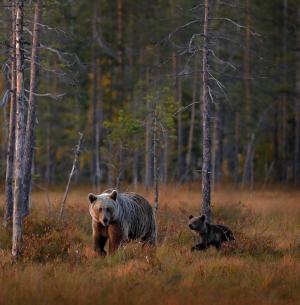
[88,191,117,227]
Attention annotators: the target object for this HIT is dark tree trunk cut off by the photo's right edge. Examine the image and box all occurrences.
[294,6,300,185]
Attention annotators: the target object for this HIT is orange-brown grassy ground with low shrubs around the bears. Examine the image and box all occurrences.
[0,184,300,305]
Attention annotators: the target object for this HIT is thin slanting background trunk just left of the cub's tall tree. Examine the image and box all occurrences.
[186,58,198,171]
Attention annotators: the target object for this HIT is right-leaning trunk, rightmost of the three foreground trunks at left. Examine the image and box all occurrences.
[23,0,41,216]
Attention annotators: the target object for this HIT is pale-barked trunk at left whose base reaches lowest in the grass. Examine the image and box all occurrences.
[12,0,25,258]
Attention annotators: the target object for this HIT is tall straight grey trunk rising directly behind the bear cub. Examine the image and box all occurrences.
[202,0,211,222]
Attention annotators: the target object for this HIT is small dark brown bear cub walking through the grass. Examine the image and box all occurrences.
[189,215,235,251]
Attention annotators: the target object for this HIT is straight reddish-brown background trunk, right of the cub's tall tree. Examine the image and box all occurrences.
[242,0,252,184]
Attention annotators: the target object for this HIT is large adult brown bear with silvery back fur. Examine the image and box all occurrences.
[88,190,156,255]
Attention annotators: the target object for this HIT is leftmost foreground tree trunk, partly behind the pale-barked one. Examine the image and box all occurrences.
[4,1,16,225]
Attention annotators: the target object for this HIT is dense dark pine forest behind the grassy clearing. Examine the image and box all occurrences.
[0,0,300,187]
